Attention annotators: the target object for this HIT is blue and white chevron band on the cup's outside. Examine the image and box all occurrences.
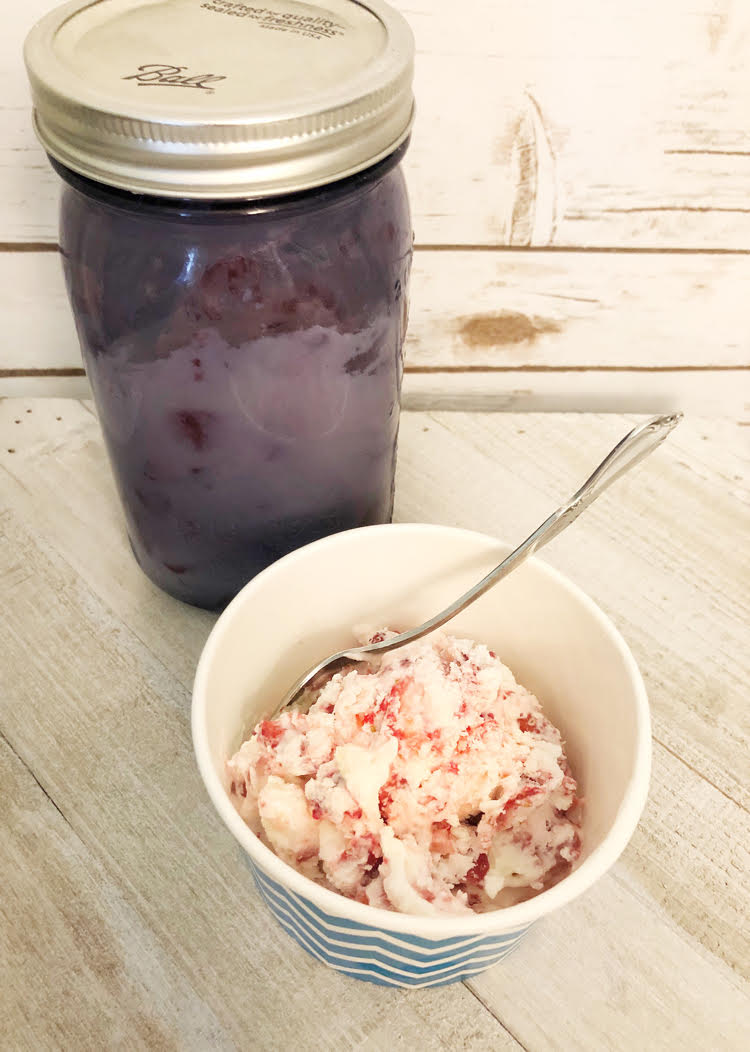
[247,859,528,988]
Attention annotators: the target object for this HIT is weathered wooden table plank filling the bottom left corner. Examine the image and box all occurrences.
[0,732,235,1052]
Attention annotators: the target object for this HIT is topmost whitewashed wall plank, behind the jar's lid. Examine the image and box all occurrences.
[0,0,750,249]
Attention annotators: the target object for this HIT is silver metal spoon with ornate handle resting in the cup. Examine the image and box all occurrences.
[273,412,683,715]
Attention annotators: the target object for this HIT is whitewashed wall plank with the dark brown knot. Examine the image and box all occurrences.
[0,250,750,370]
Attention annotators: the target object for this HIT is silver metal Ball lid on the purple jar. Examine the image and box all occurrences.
[24,0,414,200]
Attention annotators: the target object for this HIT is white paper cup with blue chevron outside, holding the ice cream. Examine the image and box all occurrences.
[192,524,650,987]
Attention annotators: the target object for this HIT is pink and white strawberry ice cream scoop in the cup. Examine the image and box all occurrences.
[227,632,581,915]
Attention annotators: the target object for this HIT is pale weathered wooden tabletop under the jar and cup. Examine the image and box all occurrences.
[0,399,750,1052]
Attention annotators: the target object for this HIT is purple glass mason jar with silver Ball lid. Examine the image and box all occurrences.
[26,0,413,608]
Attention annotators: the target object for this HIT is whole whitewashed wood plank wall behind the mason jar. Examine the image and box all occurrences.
[7,0,750,408]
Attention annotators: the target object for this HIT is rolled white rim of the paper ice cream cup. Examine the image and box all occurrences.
[191,523,651,939]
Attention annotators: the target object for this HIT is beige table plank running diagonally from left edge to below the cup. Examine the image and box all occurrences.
[0,502,518,1050]
